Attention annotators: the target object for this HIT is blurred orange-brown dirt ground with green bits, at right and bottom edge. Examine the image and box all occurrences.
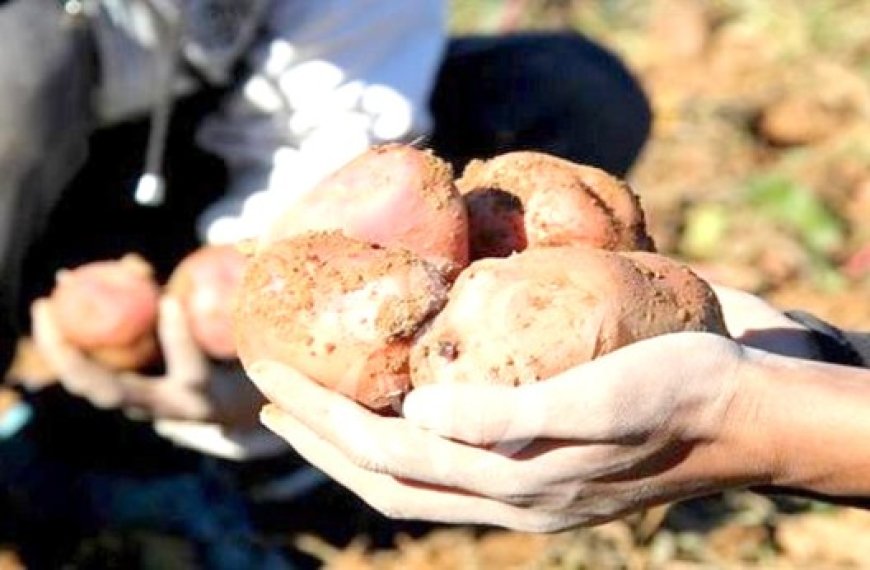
[293,0,870,570]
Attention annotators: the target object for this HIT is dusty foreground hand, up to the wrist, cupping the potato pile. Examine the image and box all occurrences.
[249,333,772,531]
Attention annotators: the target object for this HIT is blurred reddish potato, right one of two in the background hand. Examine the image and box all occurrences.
[166,244,247,360]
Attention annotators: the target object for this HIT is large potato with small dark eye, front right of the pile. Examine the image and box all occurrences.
[410,246,727,386]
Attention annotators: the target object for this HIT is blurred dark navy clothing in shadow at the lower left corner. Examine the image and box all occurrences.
[0,388,289,570]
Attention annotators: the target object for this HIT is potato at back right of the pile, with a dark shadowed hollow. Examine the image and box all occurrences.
[456,151,655,259]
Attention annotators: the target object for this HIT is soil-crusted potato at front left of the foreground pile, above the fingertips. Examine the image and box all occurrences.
[234,231,448,410]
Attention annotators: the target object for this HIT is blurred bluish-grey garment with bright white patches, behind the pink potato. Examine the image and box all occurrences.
[198,0,447,243]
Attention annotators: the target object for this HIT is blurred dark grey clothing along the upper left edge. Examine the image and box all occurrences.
[0,0,96,370]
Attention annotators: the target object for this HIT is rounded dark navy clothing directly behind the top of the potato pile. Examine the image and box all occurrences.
[431,32,651,176]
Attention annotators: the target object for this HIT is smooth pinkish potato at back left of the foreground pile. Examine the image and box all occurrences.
[261,144,468,271]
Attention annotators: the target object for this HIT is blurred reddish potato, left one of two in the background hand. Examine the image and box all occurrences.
[49,254,160,370]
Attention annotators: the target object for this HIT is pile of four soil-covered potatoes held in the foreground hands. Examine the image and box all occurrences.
[234,144,727,411]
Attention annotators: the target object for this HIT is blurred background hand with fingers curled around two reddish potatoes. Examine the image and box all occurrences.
[32,297,262,427]
